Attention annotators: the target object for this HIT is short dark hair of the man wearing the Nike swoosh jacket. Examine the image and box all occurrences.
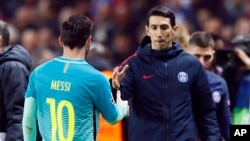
[147,6,175,27]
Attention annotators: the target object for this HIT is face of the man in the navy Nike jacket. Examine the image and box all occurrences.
[145,16,178,50]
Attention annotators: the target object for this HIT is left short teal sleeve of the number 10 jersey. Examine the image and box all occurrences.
[25,72,36,98]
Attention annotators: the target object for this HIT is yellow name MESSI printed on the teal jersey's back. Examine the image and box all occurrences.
[50,80,71,92]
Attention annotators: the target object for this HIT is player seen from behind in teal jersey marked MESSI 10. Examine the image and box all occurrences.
[23,15,128,141]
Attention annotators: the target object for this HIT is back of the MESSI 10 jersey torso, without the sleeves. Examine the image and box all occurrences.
[33,57,104,141]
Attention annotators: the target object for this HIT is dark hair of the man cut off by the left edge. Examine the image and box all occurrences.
[0,20,10,46]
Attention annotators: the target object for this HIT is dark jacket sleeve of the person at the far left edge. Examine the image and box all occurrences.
[2,62,29,141]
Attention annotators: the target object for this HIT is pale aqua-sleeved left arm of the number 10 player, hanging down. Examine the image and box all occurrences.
[22,97,37,141]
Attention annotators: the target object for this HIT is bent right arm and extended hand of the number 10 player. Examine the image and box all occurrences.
[94,76,128,124]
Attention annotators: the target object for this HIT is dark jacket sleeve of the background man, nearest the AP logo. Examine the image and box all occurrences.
[217,81,232,141]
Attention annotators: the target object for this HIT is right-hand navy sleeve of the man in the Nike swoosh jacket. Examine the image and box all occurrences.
[191,64,220,141]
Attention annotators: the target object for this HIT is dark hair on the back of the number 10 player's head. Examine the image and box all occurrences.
[60,15,93,49]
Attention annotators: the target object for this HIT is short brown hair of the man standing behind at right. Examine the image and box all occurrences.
[189,31,214,48]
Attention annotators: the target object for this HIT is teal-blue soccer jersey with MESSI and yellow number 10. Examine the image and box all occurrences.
[25,57,126,141]
